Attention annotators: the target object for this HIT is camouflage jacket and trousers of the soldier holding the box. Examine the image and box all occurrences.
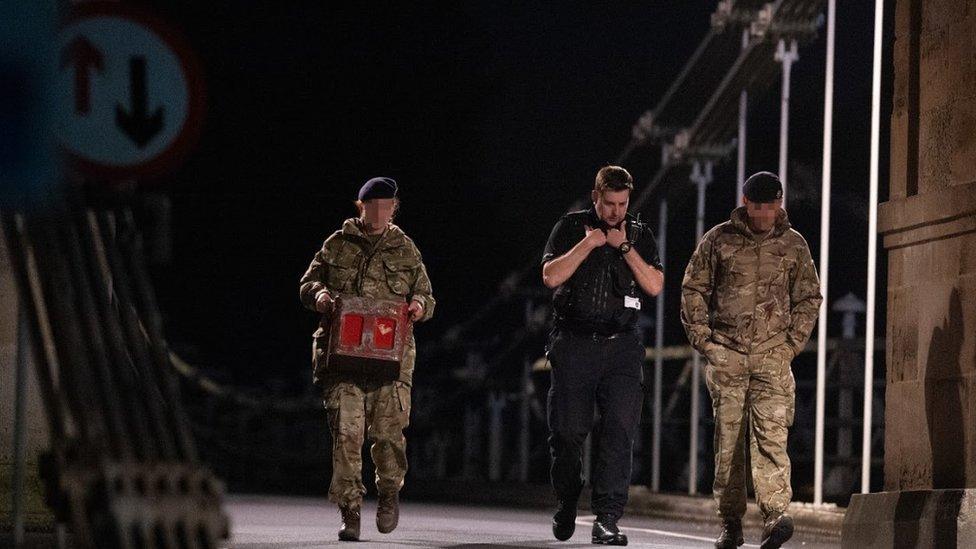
[300,219,435,506]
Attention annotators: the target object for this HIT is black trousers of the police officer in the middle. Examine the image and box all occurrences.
[548,328,644,520]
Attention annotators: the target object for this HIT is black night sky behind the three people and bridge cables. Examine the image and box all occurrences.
[137,0,890,385]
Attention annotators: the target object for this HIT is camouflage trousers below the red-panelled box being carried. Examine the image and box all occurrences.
[325,381,410,506]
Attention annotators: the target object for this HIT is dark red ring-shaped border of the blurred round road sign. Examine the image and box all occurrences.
[61,2,206,180]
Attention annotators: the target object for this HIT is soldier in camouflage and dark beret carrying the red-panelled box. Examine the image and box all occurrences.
[299,177,435,541]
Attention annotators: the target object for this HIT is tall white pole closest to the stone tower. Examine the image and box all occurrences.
[861,0,884,494]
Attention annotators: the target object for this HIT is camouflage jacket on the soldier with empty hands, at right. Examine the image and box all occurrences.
[681,208,823,356]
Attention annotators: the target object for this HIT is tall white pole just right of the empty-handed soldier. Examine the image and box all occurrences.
[813,0,836,505]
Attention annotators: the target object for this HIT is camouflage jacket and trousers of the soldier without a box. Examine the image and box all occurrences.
[681,208,822,519]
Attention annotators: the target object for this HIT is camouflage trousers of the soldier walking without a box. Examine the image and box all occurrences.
[705,344,796,520]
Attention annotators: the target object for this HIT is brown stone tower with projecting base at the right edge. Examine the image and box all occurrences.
[843,0,976,547]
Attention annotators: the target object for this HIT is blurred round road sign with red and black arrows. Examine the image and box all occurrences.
[57,2,203,178]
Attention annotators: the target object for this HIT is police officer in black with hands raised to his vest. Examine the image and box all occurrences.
[542,166,664,545]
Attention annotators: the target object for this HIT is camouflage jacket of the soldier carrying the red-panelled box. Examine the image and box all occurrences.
[299,219,435,337]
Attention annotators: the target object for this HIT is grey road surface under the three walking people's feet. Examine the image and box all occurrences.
[224,496,837,549]
